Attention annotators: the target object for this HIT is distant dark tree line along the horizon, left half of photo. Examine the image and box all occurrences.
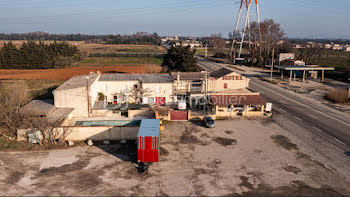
[0,32,161,45]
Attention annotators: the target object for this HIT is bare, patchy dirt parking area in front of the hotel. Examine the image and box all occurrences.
[0,119,350,196]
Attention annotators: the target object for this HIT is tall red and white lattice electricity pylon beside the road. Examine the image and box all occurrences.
[230,0,261,63]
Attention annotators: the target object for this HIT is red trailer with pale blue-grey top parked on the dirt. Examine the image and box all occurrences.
[137,119,160,173]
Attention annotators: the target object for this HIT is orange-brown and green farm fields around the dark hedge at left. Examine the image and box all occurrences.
[0,41,166,80]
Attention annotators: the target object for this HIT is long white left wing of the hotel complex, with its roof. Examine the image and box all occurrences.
[53,73,175,117]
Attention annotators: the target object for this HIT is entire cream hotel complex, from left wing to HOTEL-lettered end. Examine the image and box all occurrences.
[53,68,263,119]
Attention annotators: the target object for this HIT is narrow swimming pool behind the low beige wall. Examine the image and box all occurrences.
[75,120,141,127]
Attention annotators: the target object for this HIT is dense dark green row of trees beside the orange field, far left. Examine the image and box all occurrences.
[0,41,80,69]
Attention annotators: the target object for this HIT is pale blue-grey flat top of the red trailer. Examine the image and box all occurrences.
[137,119,160,137]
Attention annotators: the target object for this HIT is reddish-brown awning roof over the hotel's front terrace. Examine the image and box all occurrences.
[210,95,266,106]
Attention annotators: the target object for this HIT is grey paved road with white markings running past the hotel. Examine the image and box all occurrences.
[198,58,350,151]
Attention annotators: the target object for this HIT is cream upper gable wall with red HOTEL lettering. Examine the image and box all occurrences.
[208,73,250,92]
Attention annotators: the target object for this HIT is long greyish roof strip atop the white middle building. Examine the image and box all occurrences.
[99,73,174,83]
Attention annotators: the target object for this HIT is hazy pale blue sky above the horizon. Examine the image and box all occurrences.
[0,0,350,38]
